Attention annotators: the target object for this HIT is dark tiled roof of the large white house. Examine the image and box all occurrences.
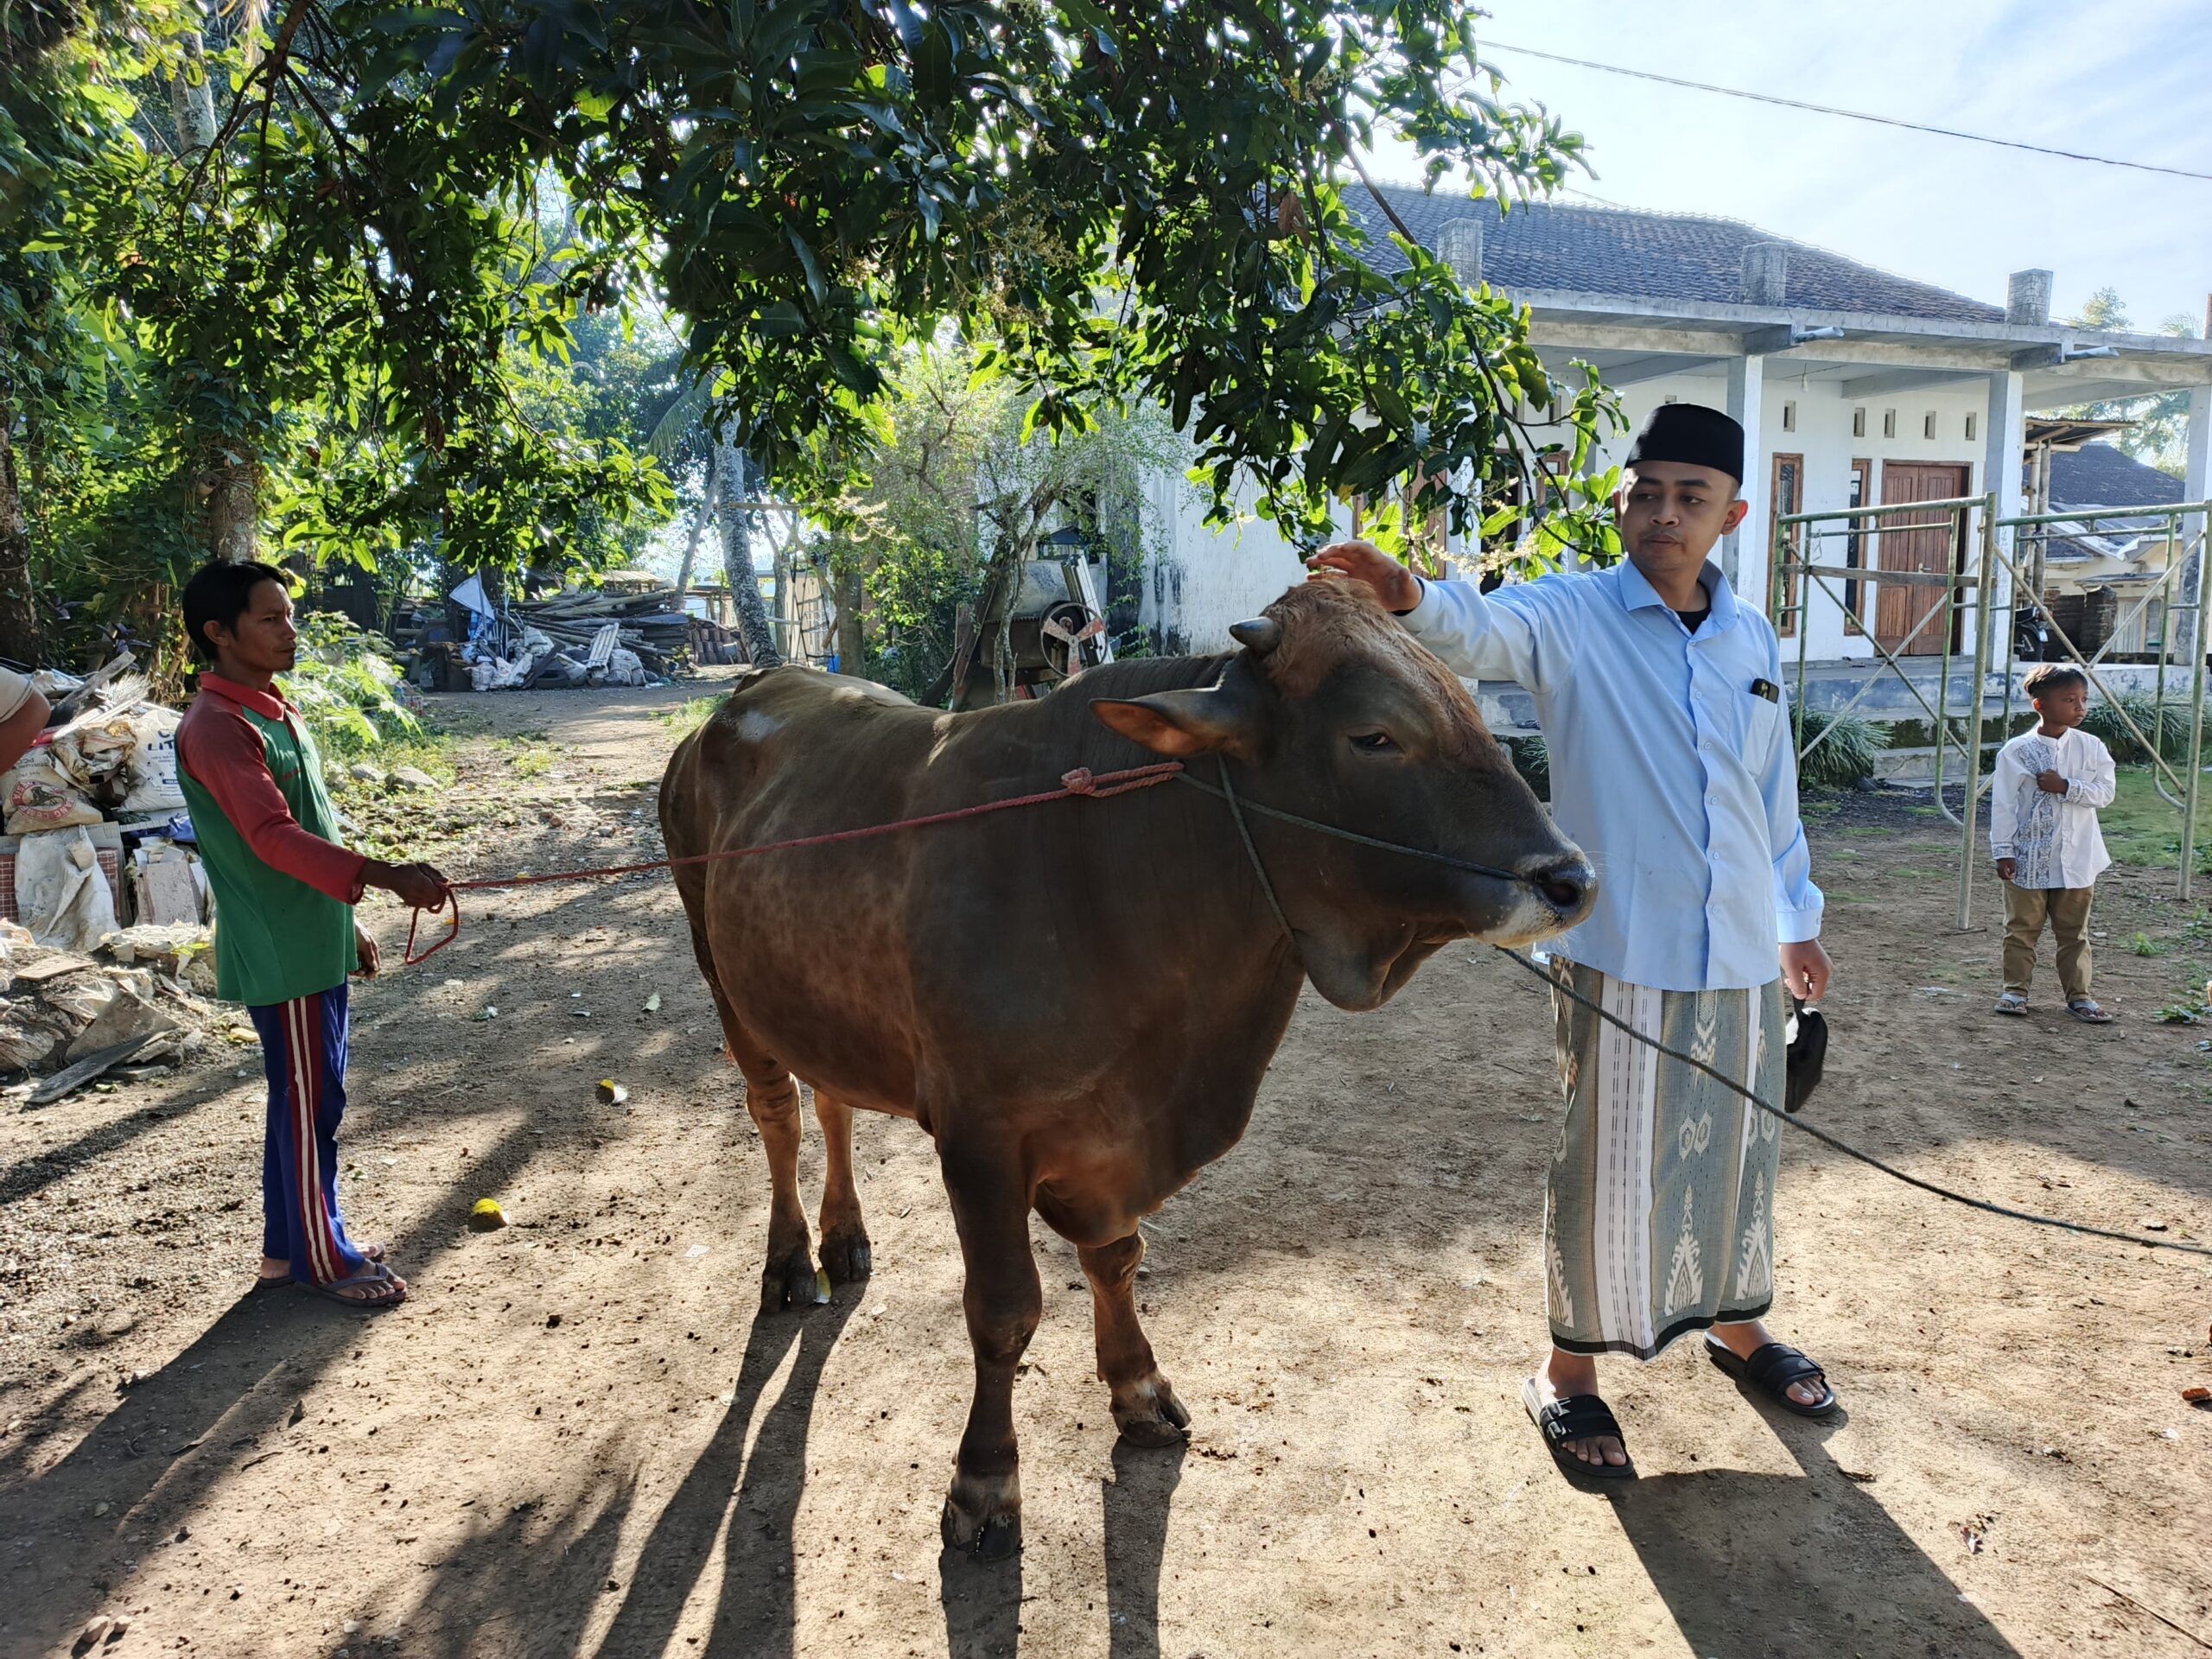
[1347,183,2004,323]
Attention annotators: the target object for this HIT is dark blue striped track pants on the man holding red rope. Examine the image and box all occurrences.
[245,982,367,1285]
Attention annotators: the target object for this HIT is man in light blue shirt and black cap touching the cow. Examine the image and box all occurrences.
[1314,404,1836,1478]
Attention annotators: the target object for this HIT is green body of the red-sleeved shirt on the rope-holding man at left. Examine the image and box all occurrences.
[177,692,356,1008]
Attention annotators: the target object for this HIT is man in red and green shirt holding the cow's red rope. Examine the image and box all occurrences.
[177,564,445,1307]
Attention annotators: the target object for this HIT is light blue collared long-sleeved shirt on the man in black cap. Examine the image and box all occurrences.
[1405,560,1821,991]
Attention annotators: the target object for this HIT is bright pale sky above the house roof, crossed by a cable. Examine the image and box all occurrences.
[1376,0,2212,332]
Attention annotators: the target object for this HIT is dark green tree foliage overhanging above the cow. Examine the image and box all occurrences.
[353,0,1595,559]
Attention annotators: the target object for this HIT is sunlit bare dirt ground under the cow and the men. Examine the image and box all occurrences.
[0,688,2212,1659]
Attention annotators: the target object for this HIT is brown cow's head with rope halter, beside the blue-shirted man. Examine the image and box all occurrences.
[1093,580,1597,1026]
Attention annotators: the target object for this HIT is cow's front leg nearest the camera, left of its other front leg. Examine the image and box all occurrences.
[943,1146,1044,1561]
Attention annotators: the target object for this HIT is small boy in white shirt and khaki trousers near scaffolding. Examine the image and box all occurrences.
[1988,664,2117,1027]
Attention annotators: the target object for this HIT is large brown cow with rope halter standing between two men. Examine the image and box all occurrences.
[661,582,1595,1555]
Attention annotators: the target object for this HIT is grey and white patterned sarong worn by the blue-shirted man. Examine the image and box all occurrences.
[1544,963,1787,1360]
